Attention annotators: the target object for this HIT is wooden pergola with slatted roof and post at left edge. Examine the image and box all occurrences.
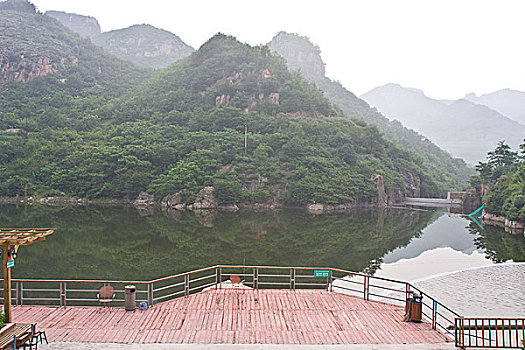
[0,228,55,323]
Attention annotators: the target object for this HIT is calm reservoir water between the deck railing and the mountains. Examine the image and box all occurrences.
[0,204,525,316]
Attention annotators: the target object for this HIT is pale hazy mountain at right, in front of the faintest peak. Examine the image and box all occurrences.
[361,84,525,164]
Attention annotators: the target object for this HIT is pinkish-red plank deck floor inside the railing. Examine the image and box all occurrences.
[13,289,445,344]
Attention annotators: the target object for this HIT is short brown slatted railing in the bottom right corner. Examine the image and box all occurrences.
[454,317,525,349]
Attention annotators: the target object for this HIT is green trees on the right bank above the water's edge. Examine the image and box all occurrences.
[471,140,525,221]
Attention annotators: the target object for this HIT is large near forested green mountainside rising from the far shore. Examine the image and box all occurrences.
[0,4,443,205]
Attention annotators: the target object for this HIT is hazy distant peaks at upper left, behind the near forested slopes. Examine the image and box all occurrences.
[46,11,195,68]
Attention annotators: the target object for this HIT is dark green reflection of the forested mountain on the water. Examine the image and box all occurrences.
[0,205,520,280]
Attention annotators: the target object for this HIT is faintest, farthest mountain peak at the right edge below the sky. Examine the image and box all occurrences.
[464,89,525,125]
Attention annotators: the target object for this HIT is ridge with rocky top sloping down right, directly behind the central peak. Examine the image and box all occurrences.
[268,32,473,191]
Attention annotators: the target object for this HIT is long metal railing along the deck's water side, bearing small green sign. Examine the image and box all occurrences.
[0,265,460,337]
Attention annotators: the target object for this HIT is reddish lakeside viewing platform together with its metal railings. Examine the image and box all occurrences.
[2,265,525,348]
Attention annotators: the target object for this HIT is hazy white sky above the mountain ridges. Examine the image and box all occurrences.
[28,0,525,99]
